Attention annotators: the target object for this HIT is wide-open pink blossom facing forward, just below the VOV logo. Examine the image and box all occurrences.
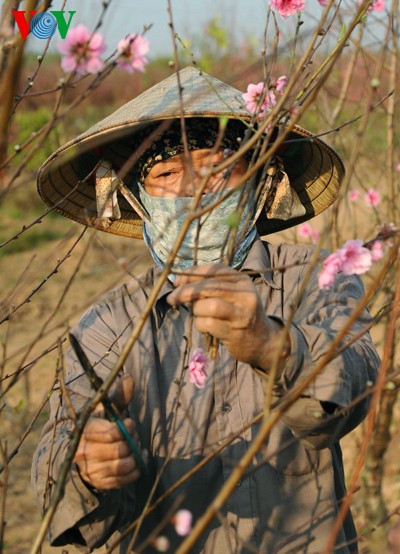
[57,24,106,75]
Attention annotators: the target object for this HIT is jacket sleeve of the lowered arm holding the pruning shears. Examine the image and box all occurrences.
[32,304,135,548]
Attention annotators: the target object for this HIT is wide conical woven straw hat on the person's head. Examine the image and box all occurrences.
[37,67,344,238]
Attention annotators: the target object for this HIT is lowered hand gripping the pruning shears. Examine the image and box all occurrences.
[74,375,140,491]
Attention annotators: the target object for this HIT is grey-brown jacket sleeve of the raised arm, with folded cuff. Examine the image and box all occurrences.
[275,250,380,448]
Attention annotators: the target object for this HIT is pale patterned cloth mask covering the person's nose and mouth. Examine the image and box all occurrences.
[139,184,257,271]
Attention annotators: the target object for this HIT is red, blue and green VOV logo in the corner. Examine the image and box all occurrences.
[11,10,76,40]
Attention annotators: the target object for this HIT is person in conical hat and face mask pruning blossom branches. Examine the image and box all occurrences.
[32,67,379,553]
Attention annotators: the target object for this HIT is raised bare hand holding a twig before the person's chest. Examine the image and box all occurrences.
[167,264,289,370]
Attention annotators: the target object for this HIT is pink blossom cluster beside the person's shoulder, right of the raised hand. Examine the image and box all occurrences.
[318,240,383,290]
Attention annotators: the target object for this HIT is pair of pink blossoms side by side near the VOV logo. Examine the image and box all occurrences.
[58,24,149,75]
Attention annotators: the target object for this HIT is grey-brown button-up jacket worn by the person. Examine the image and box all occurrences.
[32,240,379,554]
